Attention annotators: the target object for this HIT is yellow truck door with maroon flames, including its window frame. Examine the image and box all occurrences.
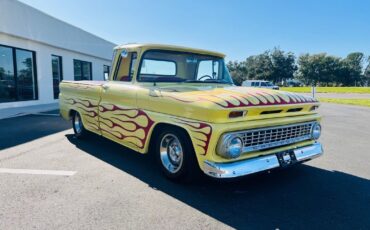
[99,51,141,149]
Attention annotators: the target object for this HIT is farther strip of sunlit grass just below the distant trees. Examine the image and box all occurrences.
[280,87,370,93]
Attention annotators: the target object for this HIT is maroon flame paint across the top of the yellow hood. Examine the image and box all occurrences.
[162,90,317,108]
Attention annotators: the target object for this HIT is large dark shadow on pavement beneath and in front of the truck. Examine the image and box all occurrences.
[66,135,370,229]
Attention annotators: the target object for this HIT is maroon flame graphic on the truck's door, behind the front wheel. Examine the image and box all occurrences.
[99,104,154,149]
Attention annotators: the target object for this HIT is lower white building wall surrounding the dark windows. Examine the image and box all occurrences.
[0,33,112,109]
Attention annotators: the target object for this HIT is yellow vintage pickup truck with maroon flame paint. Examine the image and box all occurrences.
[60,44,323,180]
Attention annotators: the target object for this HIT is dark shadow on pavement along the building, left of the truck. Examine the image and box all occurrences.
[0,113,71,150]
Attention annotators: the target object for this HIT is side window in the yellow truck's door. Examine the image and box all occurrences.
[113,52,137,82]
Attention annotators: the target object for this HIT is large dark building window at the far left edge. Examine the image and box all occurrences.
[0,45,37,103]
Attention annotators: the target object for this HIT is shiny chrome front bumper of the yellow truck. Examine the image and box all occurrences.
[203,142,323,178]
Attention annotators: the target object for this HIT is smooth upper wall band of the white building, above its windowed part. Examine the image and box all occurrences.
[0,0,115,59]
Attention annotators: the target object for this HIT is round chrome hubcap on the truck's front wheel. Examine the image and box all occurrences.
[159,134,183,173]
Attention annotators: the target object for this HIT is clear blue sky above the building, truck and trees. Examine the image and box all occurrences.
[22,0,370,60]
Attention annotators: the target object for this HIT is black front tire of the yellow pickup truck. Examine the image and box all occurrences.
[155,127,200,181]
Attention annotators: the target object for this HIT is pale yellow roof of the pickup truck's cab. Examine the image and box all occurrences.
[114,43,225,58]
